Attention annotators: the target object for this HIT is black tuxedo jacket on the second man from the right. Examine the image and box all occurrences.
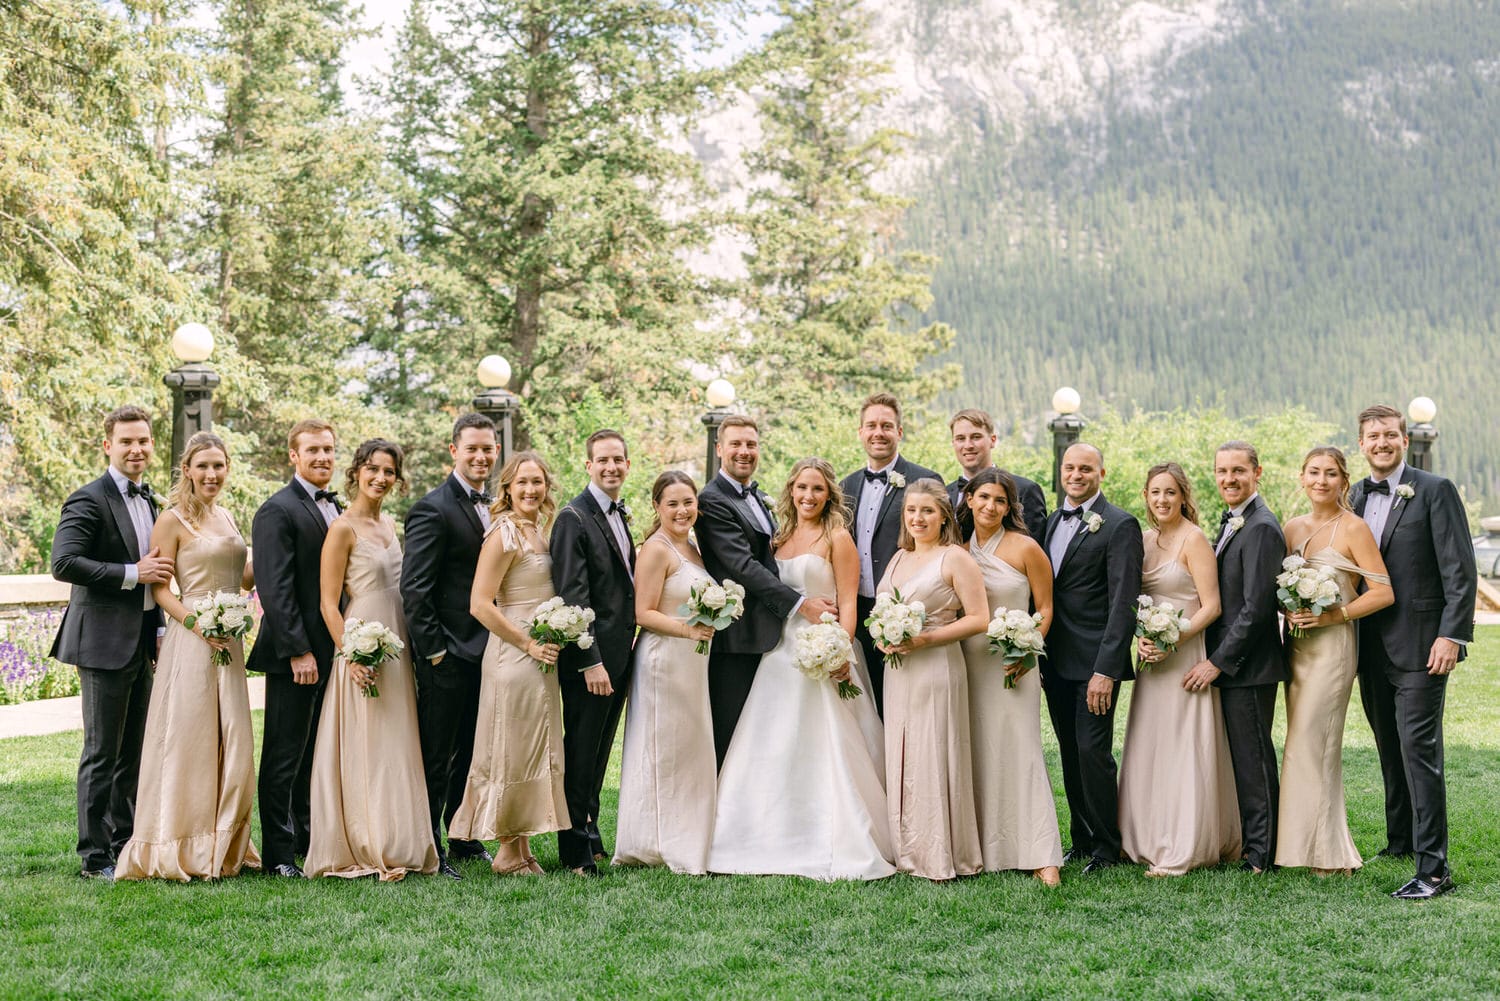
[1205,497,1287,689]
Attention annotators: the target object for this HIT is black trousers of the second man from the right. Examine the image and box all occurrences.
[1220,681,1281,869]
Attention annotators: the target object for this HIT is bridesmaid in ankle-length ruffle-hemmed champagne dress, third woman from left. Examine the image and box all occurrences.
[449,452,570,876]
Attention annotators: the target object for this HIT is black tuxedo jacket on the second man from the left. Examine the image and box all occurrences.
[245,480,338,677]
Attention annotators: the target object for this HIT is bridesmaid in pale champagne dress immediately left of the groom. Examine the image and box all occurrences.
[614,470,719,875]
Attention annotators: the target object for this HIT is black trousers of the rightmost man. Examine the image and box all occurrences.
[1359,651,1448,876]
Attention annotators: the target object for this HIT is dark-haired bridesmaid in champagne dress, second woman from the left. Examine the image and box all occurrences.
[303,438,438,881]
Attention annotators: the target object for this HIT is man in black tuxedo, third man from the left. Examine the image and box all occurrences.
[401,414,498,879]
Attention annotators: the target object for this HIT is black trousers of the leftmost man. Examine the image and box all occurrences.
[78,614,156,869]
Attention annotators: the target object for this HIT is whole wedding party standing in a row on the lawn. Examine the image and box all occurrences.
[53,393,1476,899]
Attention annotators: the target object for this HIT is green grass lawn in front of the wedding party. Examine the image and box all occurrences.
[0,627,1500,999]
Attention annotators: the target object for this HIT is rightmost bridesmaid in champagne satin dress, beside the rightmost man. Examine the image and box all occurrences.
[1277,446,1395,875]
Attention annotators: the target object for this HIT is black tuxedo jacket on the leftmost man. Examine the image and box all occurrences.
[53,473,162,671]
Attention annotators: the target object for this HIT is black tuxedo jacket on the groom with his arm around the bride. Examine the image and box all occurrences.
[696,473,803,654]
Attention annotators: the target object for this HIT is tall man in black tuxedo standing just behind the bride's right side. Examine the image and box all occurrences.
[839,393,942,717]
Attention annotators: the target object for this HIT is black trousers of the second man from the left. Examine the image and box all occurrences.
[255,668,329,870]
